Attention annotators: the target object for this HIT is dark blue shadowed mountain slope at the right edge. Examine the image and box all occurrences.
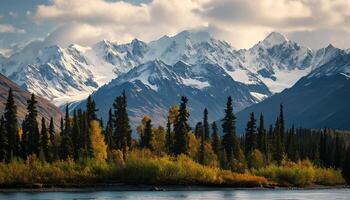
[237,51,350,133]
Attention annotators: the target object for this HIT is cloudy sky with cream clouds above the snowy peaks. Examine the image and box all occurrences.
[0,0,350,55]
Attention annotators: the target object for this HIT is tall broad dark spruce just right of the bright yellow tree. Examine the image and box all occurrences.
[113,91,131,155]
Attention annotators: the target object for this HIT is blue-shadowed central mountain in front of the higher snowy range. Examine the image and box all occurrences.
[75,59,271,125]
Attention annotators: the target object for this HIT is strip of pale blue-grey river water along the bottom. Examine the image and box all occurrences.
[0,189,350,200]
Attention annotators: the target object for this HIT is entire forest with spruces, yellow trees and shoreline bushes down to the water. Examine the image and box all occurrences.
[0,90,350,187]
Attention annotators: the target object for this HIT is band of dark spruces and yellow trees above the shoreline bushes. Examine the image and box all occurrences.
[0,90,350,185]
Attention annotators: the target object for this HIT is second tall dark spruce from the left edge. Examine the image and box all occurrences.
[23,94,41,156]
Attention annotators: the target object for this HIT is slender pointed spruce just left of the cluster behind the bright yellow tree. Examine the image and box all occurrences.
[60,105,74,160]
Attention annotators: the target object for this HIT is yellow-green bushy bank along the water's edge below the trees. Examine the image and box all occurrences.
[0,151,344,187]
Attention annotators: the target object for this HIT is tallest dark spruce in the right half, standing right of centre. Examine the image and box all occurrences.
[222,96,240,162]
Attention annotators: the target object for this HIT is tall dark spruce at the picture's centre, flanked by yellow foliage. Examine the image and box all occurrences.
[174,96,190,155]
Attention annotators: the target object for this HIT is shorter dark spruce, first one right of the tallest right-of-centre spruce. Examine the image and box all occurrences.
[245,113,256,157]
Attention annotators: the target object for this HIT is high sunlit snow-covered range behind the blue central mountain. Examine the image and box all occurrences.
[0,31,347,115]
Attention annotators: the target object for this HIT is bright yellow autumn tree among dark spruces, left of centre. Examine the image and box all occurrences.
[90,120,107,161]
